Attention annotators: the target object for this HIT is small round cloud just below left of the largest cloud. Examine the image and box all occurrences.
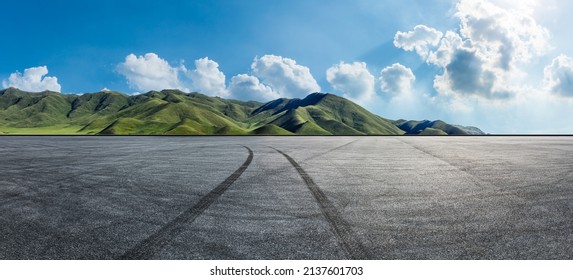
[380,63,416,95]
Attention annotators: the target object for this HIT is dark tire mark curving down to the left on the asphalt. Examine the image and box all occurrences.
[116,146,253,260]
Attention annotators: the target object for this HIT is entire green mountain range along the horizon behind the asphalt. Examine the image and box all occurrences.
[0,88,484,135]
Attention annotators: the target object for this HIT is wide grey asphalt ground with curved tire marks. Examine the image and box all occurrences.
[0,137,573,260]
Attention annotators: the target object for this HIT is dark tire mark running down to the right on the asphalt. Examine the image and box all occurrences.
[273,148,369,260]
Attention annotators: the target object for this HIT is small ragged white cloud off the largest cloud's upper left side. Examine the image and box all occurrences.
[394,25,443,58]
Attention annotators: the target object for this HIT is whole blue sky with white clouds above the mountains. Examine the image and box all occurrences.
[0,0,573,133]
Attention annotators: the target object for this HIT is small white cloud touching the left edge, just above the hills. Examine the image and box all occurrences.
[2,66,62,92]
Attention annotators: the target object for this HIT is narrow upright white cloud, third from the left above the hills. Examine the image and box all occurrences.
[188,57,229,97]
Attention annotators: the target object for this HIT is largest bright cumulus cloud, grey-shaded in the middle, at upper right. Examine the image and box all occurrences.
[395,0,550,99]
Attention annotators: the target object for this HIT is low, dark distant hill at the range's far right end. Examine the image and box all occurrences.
[394,120,485,135]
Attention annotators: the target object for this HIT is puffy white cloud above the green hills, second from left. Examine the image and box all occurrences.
[117,53,188,91]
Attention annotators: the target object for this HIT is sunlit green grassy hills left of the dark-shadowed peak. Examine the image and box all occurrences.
[0,88,262,135]
